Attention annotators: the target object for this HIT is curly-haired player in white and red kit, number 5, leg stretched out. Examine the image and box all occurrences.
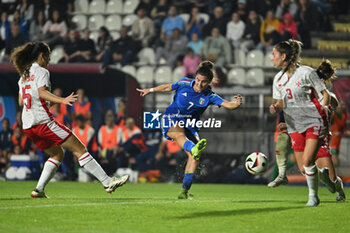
[11,42,128,198]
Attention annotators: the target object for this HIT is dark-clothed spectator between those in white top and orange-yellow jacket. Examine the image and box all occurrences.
[241,11,261,53]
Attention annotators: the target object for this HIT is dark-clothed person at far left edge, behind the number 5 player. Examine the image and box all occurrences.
[0,118,13,166]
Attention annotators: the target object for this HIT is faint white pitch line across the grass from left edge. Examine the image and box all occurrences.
[0,200,232,210]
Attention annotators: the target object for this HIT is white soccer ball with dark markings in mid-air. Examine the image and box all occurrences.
[245,152,268,175]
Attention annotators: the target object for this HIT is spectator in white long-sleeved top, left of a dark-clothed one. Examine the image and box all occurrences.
[226,12,245,49]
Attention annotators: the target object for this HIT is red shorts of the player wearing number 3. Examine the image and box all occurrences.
[290,126,325,152]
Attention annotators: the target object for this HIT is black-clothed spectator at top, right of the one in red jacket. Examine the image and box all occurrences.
[296,0,320,49]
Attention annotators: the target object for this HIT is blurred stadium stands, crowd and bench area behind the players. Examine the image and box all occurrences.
[0,0,350,185]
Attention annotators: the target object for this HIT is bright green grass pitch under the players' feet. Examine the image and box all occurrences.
[0,181,350,233]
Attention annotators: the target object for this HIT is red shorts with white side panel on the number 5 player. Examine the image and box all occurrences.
[23,121,72,150]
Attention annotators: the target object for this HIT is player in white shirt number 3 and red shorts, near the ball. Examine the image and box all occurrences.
[270,40,329,207]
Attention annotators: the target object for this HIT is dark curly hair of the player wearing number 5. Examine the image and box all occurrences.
[10,42,50,78]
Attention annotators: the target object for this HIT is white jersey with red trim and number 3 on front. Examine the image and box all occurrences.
[273,66,326,133]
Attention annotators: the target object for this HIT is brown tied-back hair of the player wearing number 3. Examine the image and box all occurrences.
[275,39,303,81]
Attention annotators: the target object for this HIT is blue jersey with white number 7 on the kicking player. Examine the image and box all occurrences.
[162,78,224,139]
